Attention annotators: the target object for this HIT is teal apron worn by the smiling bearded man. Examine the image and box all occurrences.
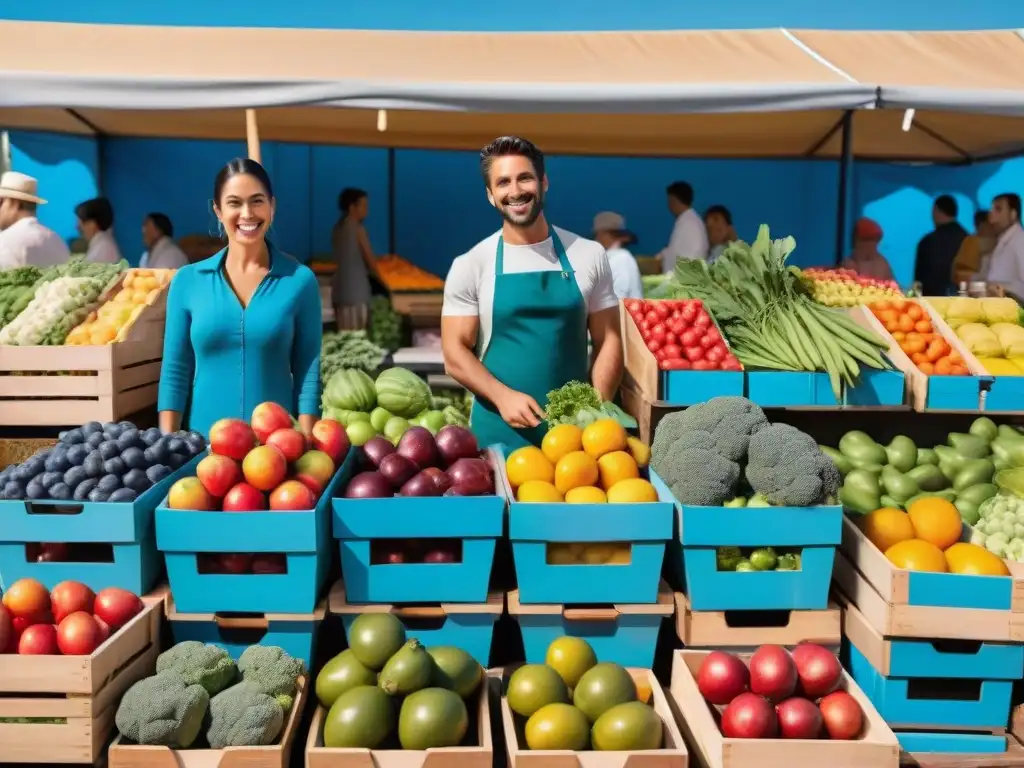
[470,227,590,451]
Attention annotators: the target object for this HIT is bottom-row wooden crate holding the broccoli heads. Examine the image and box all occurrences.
[106,678,309,768]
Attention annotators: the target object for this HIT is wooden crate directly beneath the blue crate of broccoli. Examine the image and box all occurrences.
[676,592,842,649]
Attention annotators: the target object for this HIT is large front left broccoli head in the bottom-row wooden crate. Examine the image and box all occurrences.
[114,672,210,750]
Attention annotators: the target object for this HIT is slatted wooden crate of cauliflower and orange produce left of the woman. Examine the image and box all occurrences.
[0,284,167,426]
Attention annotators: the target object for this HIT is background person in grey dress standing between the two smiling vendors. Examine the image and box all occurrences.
[331,186,377,331]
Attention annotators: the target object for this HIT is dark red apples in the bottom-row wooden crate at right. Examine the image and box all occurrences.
[696,643,864,740]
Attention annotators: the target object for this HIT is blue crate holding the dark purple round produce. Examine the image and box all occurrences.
[333,454,505,603]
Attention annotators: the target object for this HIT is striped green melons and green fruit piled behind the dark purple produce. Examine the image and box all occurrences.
[321,368,469,445]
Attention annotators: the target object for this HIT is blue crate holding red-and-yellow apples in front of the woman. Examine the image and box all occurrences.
[157,451,355,613]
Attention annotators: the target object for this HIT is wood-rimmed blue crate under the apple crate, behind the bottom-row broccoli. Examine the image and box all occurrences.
[167,603,326,669]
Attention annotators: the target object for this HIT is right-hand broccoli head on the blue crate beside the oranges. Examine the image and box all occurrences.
[746,424,843,507]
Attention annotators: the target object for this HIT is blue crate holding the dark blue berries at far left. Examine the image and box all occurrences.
[0,456,202,595]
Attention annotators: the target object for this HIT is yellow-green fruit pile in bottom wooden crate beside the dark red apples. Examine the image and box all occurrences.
[505,636,665,752]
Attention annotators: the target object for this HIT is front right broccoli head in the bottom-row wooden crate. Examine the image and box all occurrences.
[206,683,285,750]
